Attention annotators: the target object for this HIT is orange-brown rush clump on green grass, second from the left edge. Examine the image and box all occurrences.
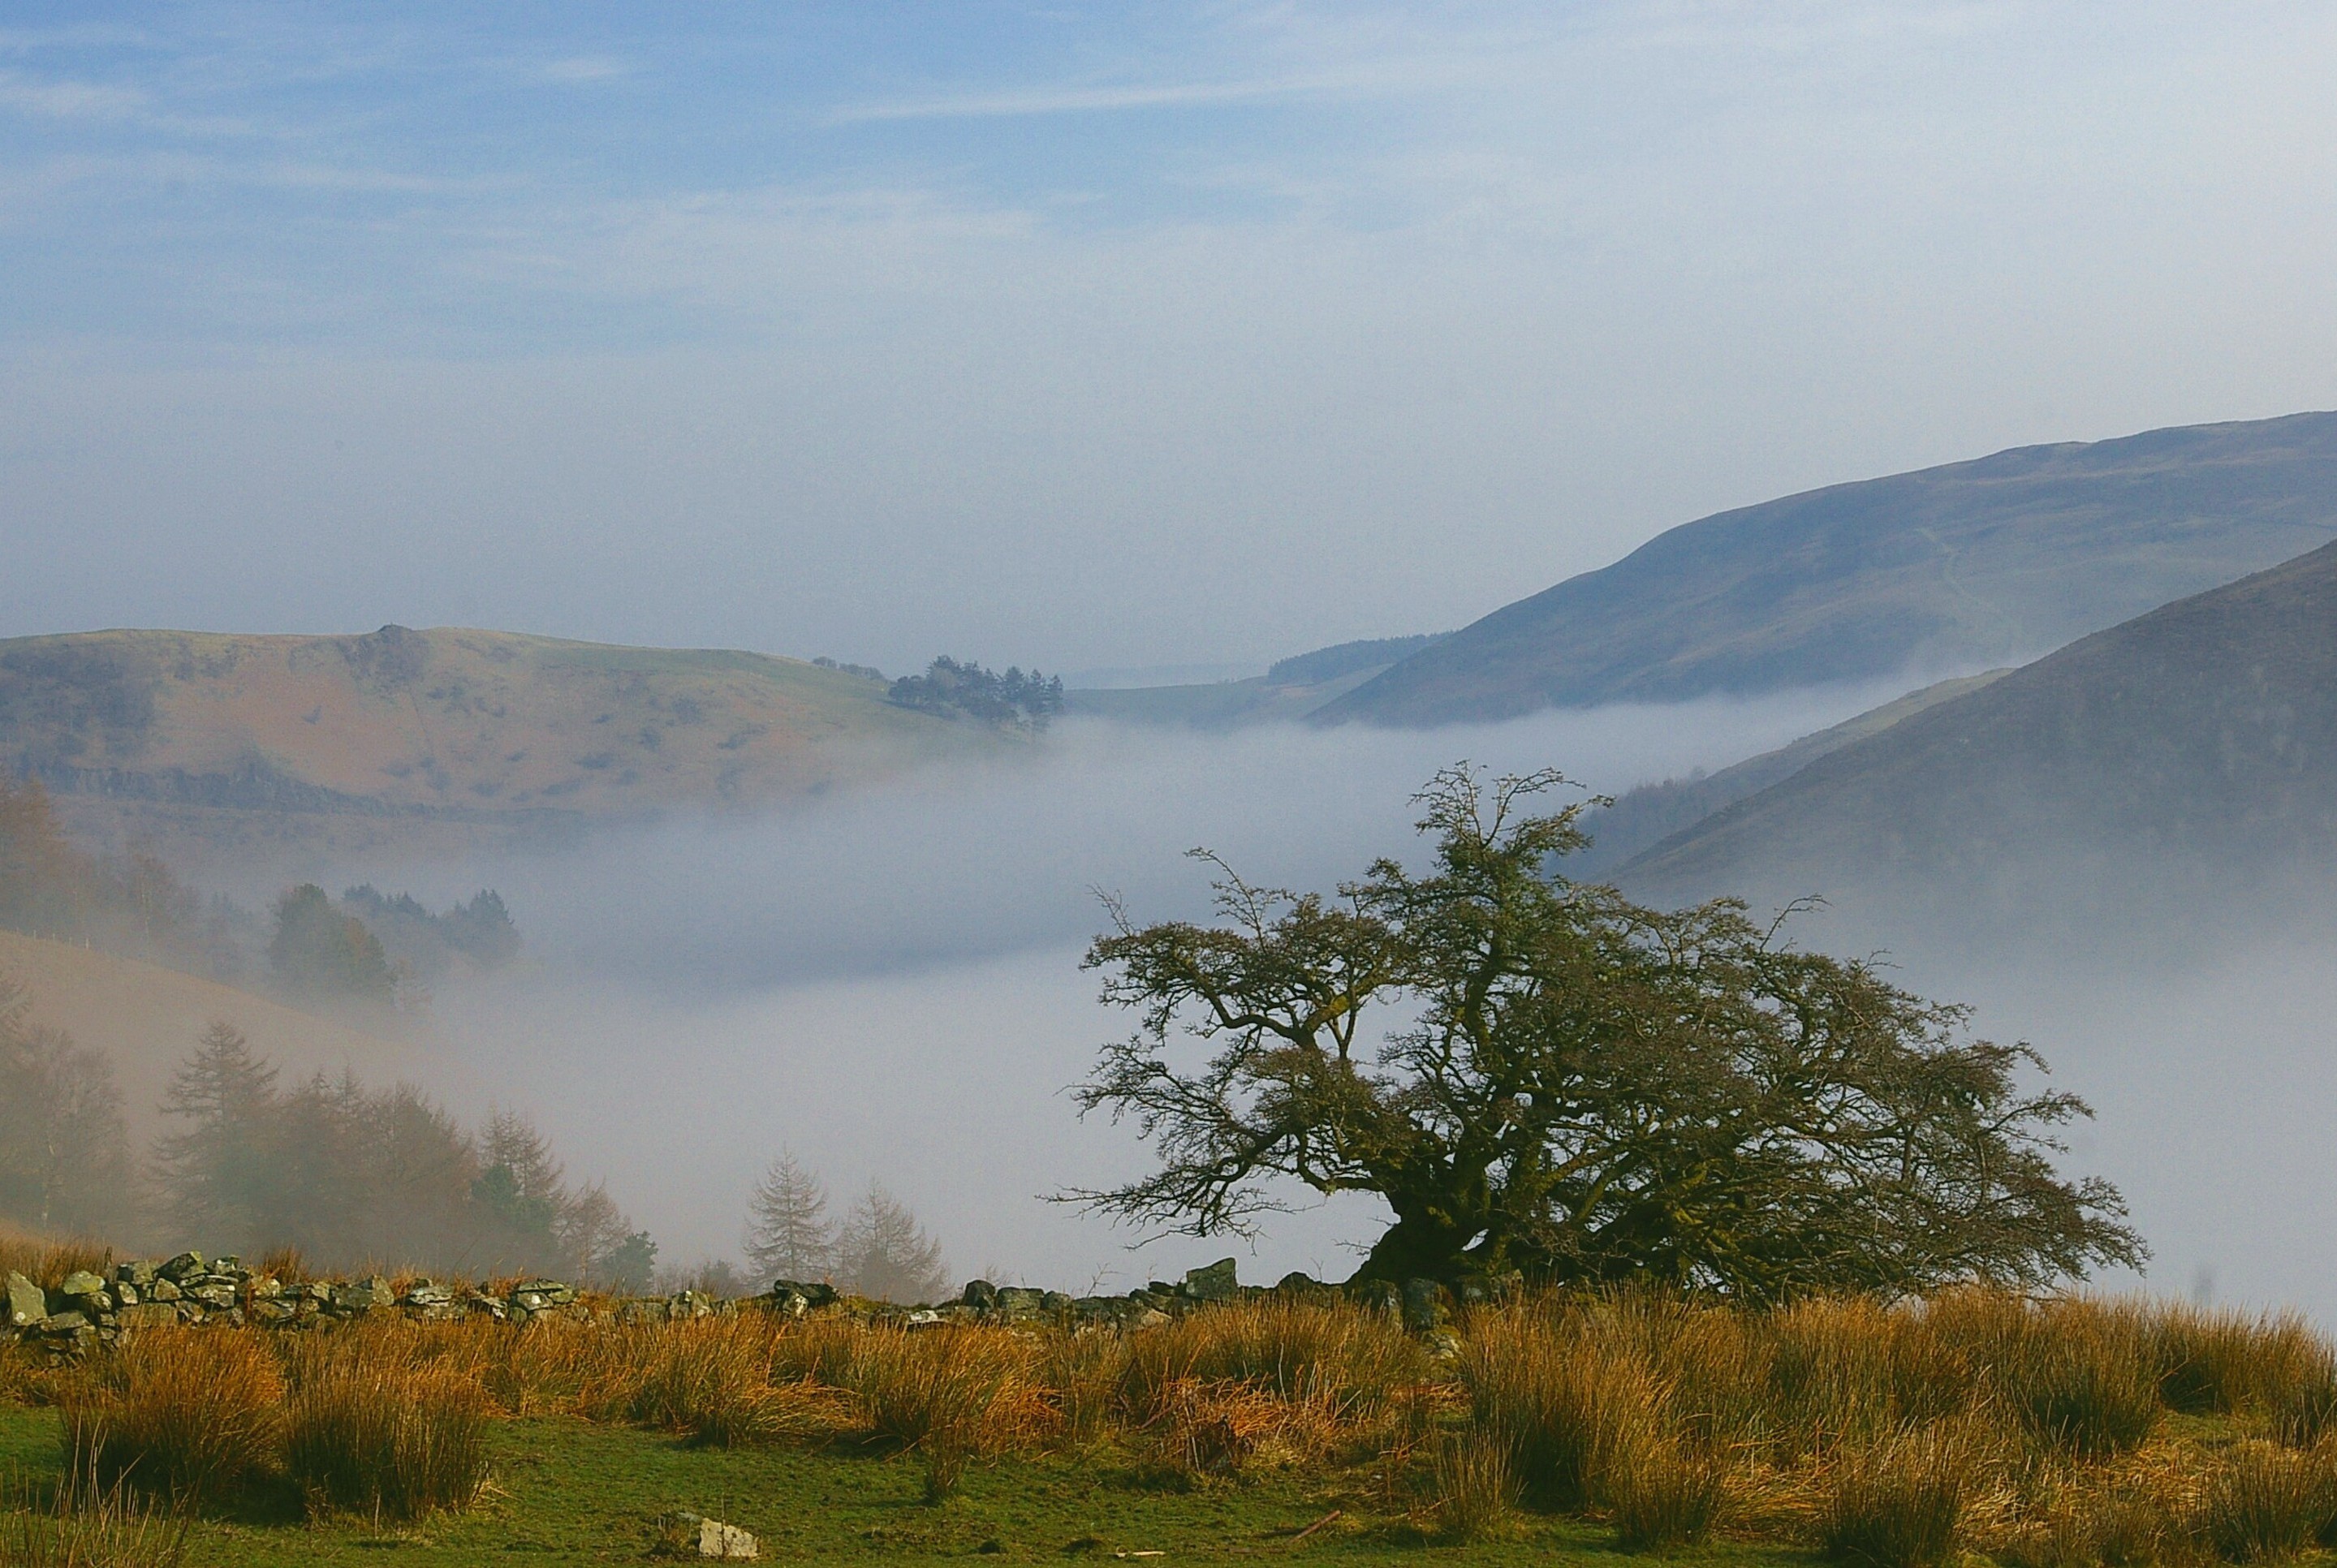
[285,1325,491,1519]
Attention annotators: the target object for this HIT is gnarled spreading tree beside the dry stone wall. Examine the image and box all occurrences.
[1066,766,2143,1299]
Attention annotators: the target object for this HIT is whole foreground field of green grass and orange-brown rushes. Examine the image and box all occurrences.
[0,1260,2337,1568]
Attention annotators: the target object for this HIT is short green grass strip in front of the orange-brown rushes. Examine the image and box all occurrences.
[0,1406,1809,1568]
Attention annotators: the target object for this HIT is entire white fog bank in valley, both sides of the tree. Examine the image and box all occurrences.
[320,689,2337,1318]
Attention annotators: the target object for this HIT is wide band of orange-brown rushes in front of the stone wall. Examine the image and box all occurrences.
[0,1252,2337,1568]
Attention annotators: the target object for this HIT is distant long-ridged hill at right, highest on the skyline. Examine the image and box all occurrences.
[1316,414,2337,725]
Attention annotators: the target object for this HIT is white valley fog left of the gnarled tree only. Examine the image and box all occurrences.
[306,683,1903,1290]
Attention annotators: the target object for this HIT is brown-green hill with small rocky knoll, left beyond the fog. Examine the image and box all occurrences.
[0,627,984,864]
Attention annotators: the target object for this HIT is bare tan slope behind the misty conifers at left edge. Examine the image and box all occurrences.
[0,930,430,1145]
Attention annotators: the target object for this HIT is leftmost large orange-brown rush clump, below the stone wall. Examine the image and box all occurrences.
[61,1327,285,1501]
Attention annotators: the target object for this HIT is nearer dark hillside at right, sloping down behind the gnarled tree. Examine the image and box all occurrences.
[1619,545,2337,907]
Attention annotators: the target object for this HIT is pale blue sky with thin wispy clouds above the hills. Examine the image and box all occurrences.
[0,0,2337,673]
